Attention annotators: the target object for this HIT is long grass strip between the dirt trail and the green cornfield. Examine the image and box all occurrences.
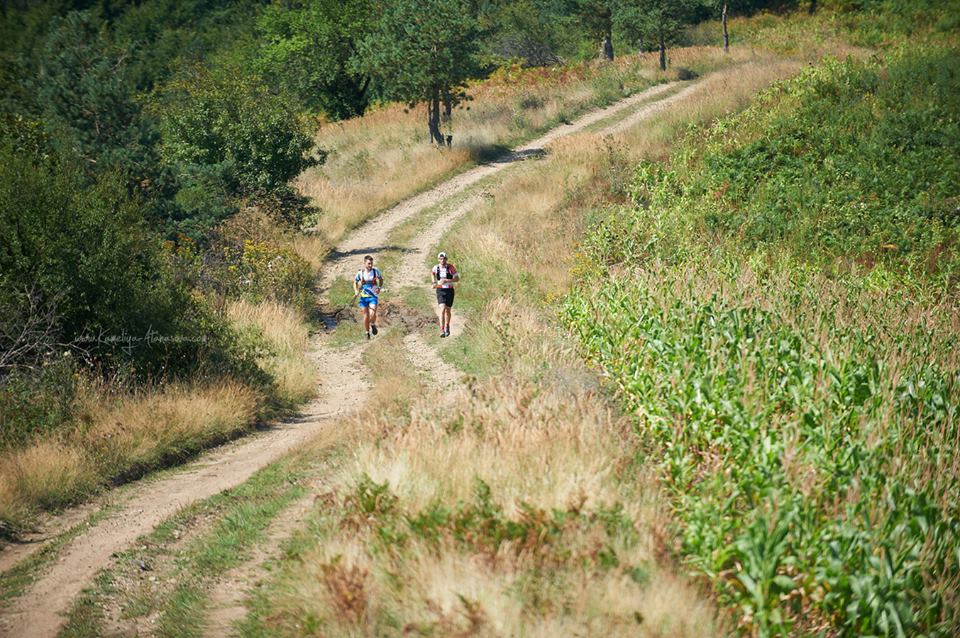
[242,51,798,636]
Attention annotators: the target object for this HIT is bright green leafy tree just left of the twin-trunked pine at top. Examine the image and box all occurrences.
[255,0,377,119]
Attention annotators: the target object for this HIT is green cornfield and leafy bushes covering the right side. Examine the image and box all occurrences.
[565,47,960,636]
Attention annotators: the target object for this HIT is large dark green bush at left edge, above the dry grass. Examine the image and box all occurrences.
[0,141,221,374]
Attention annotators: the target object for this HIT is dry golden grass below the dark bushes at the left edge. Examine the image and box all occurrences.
[0,381,260,529]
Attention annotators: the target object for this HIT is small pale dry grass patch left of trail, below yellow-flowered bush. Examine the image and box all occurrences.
[227,300,317,405]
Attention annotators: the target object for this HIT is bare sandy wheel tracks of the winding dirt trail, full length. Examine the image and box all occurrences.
[0,77,695,638]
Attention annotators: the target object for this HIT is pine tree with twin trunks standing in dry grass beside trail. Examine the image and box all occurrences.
[356,0,480,146]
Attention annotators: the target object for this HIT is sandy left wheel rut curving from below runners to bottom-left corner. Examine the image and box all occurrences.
[0,343,365,638]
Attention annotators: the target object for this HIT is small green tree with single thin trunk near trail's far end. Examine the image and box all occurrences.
[614,0,703,71]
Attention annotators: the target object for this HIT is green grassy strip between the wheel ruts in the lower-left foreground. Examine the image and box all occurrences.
[61,439,337,636]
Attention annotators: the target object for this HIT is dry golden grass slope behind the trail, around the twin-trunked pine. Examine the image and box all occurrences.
[296,53,684,242]
